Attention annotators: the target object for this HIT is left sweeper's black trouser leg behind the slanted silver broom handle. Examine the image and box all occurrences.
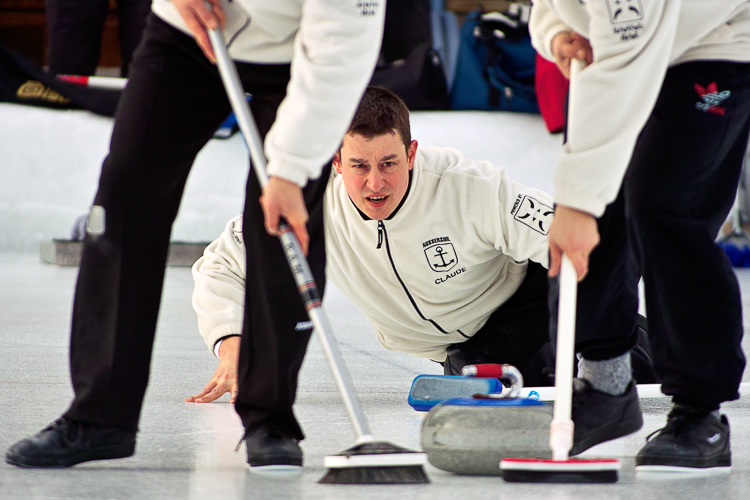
[235,154,331,440]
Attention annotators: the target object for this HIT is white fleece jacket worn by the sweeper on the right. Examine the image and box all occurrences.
[530,0,750,217]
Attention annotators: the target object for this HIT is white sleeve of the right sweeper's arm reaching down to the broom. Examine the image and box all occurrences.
[554,0,681,217]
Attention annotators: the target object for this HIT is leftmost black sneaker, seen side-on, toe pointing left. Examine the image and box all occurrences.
[5,418,135,467]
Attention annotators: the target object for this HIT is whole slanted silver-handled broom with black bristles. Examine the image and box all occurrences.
[208,23,430,484]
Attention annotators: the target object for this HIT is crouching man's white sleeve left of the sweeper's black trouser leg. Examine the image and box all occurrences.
[192,216,246,352]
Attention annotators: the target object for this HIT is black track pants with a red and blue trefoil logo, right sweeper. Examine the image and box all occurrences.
[564,61,750,410]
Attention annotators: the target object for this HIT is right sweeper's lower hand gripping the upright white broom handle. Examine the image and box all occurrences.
[548,205,599,281]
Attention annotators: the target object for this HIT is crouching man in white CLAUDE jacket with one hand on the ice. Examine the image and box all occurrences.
[186,87,656,402]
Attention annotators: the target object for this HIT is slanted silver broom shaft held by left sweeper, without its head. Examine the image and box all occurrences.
[208,30,374,443]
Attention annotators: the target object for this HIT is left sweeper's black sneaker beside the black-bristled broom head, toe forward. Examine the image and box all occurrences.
[244,422,302,471]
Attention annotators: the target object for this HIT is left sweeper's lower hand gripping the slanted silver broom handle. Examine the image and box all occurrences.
[260,176,310,255]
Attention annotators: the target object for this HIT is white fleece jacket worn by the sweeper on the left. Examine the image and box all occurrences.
[152,0,385,186]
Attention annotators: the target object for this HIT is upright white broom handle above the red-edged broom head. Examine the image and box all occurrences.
[549,58,585,461]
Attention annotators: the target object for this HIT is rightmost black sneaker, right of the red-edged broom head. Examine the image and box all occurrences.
[635,404,732,471]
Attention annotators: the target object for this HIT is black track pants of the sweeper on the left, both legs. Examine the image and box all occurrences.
[66,15,327,438]
